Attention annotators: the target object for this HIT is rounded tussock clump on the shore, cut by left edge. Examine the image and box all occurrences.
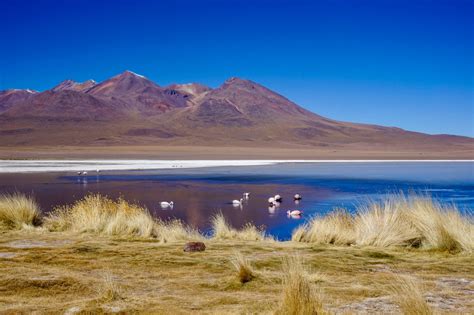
[0,193,41,230]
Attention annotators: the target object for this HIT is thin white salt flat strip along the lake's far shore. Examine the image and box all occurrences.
[0,160,474,173]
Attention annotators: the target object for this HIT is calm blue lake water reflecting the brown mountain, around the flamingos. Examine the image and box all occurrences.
[0,162,474,239]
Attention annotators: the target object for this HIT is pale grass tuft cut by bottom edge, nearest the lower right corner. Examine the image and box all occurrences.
[390,275,433,315]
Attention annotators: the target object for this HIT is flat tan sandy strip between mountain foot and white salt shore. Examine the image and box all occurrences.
[0,146,474,160]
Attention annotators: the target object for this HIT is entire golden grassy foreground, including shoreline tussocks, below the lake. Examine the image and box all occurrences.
[0,195,474,314]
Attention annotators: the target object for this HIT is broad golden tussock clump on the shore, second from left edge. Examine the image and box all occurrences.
[45,195,157,237]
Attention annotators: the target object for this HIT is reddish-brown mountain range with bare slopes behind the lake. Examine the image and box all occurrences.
[0,71,474,157]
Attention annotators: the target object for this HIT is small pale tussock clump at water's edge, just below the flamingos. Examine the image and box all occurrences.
[211,213,266,241]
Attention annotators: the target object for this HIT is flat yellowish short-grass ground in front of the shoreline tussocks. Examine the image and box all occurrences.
[0,231,474,314]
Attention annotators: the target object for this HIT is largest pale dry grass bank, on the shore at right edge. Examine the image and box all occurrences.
[292,195,474,253]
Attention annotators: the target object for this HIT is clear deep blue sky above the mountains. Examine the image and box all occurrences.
[0,0,474,136]
